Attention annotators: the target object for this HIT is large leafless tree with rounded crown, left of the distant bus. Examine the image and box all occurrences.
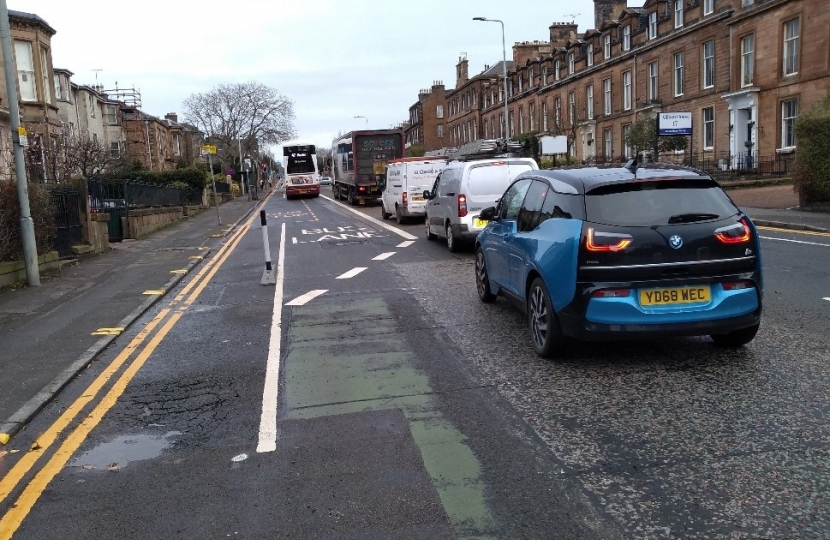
[184,81,295,166]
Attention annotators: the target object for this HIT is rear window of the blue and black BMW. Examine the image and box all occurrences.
[585,179,738,225]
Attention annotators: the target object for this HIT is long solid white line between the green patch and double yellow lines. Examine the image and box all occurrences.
[256,223,285,453]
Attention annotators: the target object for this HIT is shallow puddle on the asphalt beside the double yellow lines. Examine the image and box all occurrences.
[69,431,181,470]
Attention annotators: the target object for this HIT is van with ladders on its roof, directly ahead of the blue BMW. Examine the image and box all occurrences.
[424,157,539,252]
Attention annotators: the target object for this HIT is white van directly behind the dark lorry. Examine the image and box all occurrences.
[381,157,447,223]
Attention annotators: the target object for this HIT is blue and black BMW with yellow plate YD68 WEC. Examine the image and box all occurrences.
[475,163,763,357]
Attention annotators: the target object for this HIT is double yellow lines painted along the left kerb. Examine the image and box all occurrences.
[0,205,267,540]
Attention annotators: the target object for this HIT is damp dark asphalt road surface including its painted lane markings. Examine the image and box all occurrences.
[0,188,830,540]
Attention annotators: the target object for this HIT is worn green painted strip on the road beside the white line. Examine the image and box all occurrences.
[280,298,494,540]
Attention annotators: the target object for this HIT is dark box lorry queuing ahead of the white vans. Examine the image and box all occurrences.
[331,129,404,205]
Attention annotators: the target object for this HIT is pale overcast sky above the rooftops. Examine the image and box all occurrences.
[22,0,596,156]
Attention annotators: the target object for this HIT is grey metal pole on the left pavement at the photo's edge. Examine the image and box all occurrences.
[0,0,40,286]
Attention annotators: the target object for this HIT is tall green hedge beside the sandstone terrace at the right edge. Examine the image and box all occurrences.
[793,94,830,203]
